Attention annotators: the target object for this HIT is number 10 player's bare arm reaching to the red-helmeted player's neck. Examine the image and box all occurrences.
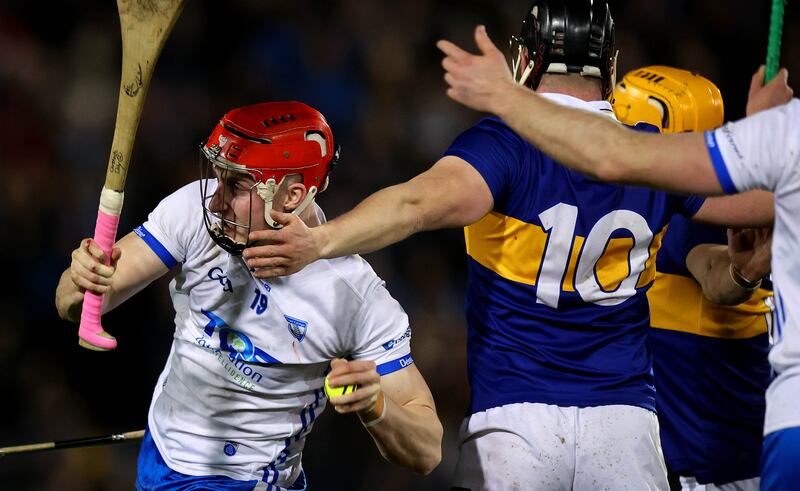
[244,156,494,278]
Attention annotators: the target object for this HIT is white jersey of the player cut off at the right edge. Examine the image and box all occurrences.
[706,99,800,434]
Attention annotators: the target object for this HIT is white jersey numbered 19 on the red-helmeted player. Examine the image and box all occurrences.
[135,181,413,487]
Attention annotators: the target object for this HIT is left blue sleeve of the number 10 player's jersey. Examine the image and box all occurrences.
[444,118,525,203]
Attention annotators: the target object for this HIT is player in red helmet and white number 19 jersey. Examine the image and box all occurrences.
[56,102,442,491]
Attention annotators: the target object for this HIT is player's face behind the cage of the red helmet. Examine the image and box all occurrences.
[209,166,264,243]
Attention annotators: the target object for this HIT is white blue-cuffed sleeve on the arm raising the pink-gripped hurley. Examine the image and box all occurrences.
[134,181,204,269]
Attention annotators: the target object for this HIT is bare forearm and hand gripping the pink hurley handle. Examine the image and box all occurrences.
[56,232,168,322]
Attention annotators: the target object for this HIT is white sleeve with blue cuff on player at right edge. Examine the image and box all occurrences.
[705,99,800,194]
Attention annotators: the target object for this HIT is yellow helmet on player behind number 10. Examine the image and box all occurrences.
[614,65,724,133]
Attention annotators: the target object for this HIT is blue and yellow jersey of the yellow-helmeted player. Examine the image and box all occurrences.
[647,217,771,484]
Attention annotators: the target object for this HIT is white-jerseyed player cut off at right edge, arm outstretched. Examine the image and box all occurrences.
[438,26,800,490]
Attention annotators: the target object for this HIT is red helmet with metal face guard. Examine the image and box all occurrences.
[200,102,339,254]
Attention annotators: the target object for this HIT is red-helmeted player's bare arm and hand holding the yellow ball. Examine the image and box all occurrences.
[328,359,443,475]
